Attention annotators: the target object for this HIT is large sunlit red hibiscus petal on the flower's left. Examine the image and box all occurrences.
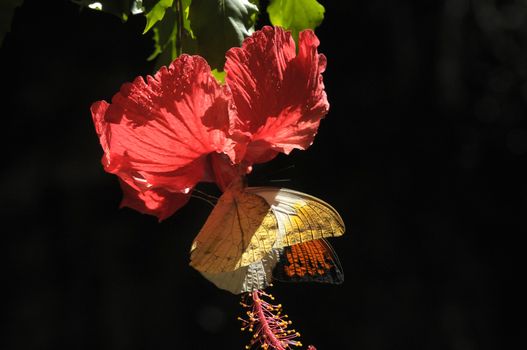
[91,55,236,216]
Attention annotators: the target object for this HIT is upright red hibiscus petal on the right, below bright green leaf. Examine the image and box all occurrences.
[225,27,329,162]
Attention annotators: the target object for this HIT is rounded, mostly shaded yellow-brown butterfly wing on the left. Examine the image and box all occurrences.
[190,191,278,274]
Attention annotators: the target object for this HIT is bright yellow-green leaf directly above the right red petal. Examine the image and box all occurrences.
[267,0,324,41]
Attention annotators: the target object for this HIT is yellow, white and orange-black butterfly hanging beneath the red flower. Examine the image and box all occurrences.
[190,185,345,294]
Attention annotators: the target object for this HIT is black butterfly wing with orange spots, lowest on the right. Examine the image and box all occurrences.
[273,238,344,284]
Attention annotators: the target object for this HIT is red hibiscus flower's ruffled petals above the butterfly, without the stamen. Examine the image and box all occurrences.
[91,27,329,220]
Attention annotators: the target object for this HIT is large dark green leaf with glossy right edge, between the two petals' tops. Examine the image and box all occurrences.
[189,0,258,70]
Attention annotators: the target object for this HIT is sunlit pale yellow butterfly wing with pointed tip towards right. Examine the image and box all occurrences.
[246,187,345,248]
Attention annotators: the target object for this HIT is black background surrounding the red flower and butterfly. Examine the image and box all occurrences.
[0,0,527,350]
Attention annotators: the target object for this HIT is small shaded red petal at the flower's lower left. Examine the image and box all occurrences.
[120,180,190,221]
